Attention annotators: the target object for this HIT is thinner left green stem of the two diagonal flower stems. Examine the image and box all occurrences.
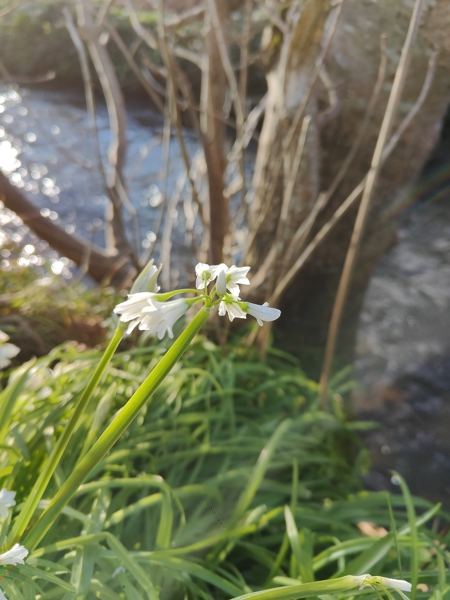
[6,324,125,548]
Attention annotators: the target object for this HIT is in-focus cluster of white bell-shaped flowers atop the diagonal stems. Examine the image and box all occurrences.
[114,262,281,340]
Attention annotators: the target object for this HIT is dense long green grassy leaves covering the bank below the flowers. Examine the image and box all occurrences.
[0,337,448,600]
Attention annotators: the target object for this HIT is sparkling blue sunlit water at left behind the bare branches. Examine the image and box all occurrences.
[0,80,197,284]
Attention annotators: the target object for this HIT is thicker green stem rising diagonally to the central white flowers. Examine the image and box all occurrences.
[23,307,210,552]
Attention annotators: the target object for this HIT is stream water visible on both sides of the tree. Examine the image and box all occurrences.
[0,87,450,505]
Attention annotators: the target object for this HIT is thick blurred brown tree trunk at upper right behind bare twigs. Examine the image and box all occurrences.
[246,0,450,375]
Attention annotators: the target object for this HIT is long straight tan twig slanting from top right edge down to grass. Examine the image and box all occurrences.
[319,0,425,409]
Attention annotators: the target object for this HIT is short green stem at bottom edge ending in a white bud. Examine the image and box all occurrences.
[230,575,359,600]
